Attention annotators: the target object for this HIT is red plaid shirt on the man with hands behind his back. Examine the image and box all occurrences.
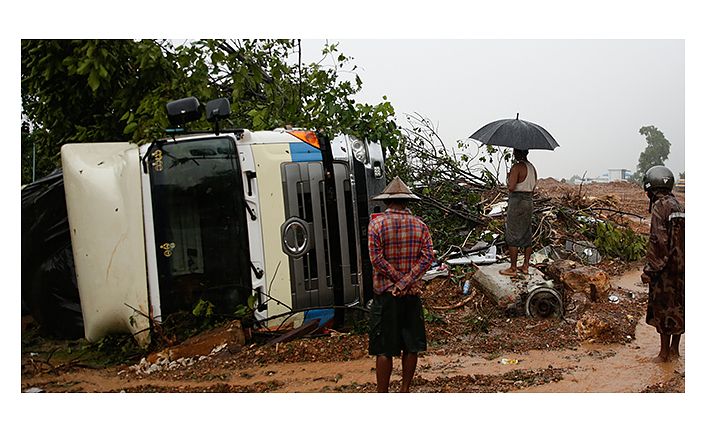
[368,209,434,294]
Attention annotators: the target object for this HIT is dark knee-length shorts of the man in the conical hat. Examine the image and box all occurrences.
[368,293,427,356]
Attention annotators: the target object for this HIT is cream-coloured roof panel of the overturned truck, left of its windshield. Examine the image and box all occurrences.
[61,143,150,347]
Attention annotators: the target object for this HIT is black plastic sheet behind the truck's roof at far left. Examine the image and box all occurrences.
[22,170,83,338]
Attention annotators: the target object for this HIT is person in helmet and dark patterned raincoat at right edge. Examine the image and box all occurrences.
[641,166,685,362]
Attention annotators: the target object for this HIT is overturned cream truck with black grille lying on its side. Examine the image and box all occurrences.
[23,97,386,346]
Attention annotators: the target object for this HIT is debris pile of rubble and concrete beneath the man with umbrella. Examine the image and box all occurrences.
[410,179,664,351]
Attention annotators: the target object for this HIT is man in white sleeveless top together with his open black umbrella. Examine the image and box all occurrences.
[471,114,559,276]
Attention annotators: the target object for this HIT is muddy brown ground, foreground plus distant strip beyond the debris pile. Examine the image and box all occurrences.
[20,180,686,393]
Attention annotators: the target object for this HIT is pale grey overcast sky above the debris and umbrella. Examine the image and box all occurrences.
[302,39,685,179]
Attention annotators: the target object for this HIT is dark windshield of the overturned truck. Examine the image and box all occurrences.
[148,137,251,318]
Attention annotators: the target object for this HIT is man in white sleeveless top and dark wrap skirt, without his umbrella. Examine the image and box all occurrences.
[500,149,537,276]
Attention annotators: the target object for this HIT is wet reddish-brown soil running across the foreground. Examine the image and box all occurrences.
[21,270,686,393]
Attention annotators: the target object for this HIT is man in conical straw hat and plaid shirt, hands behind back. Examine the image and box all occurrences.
[368,177,434,392]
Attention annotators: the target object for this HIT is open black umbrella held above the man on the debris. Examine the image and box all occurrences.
[471,114,559,150]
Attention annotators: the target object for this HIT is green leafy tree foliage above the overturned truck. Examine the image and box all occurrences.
[21,39,401,183]
